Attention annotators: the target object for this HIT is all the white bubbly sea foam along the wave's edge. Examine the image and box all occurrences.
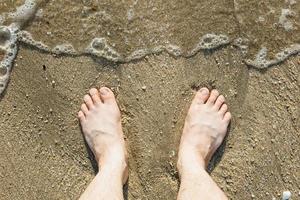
[0,0,300,94]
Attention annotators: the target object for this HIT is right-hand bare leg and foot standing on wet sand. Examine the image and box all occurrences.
[177,88,231,200]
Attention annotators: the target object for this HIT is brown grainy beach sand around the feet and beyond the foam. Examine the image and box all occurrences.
[0,0,300,200]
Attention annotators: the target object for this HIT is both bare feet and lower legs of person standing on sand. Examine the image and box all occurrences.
[78,87,231,200]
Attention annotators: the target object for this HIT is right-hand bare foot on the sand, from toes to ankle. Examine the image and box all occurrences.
[178,88,231,173]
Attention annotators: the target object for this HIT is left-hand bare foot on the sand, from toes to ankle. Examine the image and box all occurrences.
[78,87,128,183]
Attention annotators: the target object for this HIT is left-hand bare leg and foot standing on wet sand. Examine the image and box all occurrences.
[78,87,128,200]
